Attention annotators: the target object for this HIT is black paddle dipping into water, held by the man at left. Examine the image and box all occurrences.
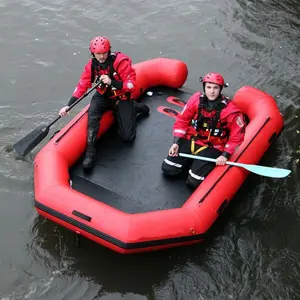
[13,81,101,156]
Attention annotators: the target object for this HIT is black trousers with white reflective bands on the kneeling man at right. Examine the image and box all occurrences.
[162,140,222,189]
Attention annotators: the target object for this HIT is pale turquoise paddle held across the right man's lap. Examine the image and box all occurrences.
[178,153,291,178]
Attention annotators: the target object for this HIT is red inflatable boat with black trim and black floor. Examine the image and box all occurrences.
[34,58,283,254]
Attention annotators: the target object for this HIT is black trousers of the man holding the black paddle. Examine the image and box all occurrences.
[87,92,149,155]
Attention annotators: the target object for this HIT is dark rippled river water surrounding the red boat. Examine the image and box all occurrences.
[0,0,300,300]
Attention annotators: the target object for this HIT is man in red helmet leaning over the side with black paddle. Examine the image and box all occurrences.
[59,36,149,170]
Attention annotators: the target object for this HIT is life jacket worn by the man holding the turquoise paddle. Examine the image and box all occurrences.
[193,95,230,145]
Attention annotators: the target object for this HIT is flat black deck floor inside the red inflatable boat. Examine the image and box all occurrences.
[70,88,192,213]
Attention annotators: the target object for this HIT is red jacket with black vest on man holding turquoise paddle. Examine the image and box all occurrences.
[173,92,246,158]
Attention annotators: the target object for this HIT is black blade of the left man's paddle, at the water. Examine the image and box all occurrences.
[13,125,49,156]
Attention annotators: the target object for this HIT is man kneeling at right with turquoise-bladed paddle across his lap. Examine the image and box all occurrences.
[162,73,246,189]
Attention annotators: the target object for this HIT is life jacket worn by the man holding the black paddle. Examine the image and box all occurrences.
[91,52,130,99]
